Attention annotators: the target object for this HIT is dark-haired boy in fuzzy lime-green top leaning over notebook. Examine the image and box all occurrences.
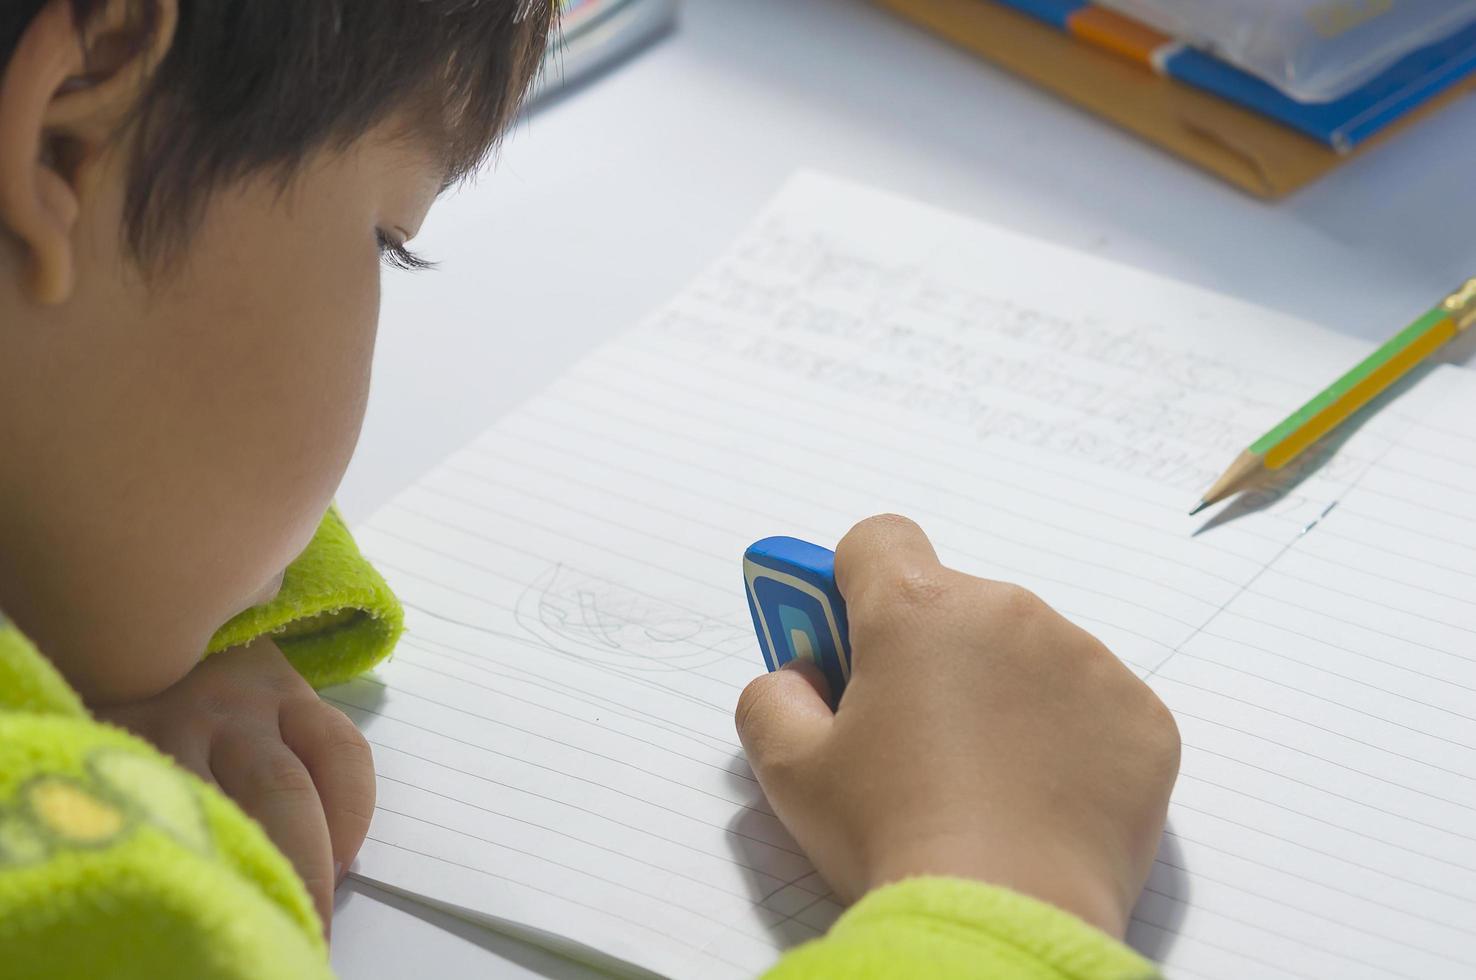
[0,0,1178,979]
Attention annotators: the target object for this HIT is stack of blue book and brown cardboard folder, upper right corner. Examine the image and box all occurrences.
[880,0,1476,198]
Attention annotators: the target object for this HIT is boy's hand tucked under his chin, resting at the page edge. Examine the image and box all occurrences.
[97,641,375,930]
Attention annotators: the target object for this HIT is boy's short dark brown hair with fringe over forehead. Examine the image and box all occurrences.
[0,0,555,258]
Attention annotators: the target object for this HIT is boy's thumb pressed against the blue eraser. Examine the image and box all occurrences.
[734,660,835,791]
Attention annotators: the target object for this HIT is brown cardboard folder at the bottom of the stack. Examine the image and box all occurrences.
[877,0,1476,199]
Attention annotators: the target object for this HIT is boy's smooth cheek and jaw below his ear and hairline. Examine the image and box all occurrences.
[0,135,395,703]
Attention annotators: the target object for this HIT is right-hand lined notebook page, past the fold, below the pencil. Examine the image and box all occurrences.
[1129,368,1476,977]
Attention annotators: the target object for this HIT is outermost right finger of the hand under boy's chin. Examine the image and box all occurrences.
[280,700,375,884]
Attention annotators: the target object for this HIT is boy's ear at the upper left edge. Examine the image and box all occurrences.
[0,0,179,304]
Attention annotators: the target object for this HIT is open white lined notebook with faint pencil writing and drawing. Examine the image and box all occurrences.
[329,176,1476,977]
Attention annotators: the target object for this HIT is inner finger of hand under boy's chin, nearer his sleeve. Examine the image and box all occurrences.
[210,734,334,934]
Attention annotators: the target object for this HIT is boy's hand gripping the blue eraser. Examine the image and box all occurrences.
[737,517,1179,937]
